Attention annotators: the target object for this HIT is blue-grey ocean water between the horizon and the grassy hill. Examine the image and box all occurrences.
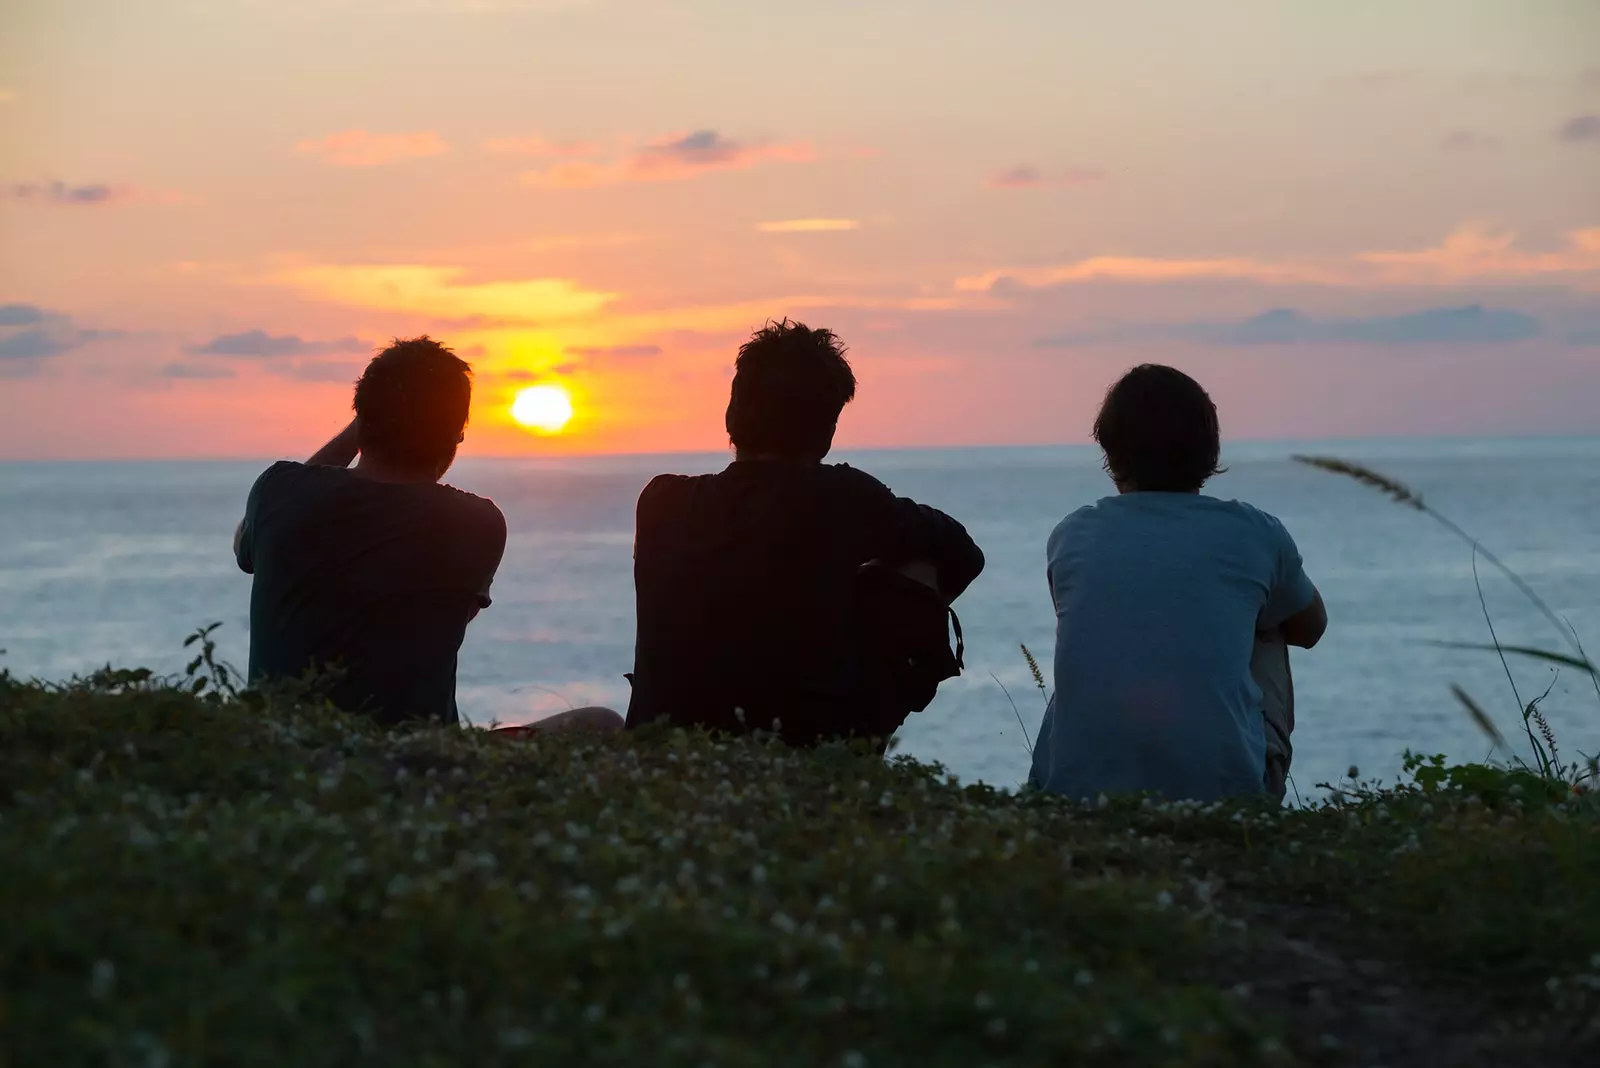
[0,440,1600,795]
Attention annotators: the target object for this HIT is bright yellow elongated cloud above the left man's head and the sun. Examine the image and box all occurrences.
[277,264,618,323]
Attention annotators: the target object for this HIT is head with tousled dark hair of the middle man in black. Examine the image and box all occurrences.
[728,320,856,459]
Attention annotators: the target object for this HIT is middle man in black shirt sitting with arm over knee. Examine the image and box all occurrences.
[627,320,984,745]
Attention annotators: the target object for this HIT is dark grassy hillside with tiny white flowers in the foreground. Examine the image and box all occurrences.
[0,671,1600,1066]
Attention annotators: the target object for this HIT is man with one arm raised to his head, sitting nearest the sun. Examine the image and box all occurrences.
[234,336,619,727]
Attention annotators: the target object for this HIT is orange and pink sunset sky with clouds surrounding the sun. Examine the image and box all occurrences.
[0,0,1600,459]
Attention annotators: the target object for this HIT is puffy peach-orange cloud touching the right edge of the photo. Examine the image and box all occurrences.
[1358,225,1600,285]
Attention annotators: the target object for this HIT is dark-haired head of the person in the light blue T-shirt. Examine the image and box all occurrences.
[1094,363,1222,492]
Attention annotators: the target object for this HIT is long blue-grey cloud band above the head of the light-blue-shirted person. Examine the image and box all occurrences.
[1037,304,1542,347]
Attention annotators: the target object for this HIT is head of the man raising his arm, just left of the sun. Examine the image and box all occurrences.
[355,334,472,478]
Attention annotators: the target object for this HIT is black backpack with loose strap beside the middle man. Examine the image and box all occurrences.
[854,561,966,725]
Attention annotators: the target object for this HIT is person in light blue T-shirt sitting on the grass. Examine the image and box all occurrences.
[1030,365,1328,801]
